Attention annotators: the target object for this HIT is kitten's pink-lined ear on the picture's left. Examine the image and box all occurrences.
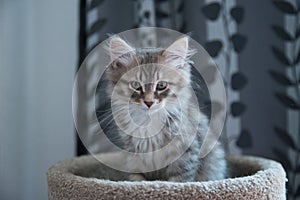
[108,36,134,61]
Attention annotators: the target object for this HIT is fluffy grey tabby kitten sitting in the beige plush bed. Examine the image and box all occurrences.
[106,36,226,182]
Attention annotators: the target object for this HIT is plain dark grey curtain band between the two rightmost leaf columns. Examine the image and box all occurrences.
[238,0,286,159]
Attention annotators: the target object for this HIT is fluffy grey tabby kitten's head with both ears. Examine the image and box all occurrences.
[107,36,194,114]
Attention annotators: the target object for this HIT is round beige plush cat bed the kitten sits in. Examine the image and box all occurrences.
[47,153,286,200]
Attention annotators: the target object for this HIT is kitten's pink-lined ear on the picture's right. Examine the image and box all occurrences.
[163,37,189,61]
